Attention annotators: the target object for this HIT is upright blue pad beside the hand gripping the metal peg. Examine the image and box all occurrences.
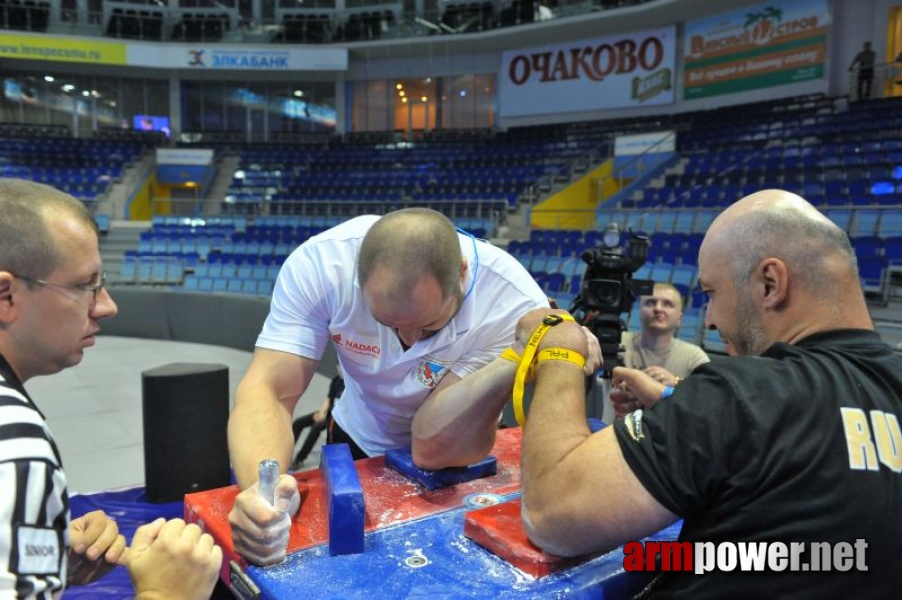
[320,444,366,556]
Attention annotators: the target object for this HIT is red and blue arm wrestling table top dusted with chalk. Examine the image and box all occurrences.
[185,428,679,599]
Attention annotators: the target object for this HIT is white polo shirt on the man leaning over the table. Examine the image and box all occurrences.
[257,215,548,456]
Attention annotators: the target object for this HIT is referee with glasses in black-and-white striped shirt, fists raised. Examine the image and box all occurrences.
[0,179,222,600]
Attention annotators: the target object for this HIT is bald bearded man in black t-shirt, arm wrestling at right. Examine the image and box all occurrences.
[518,190,902,599]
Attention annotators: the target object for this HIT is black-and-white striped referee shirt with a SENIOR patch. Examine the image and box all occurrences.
[0,356,69,600]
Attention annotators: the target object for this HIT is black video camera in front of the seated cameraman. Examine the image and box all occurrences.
[570,221,655,379]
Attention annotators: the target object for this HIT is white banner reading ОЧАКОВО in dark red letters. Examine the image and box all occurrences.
[498,27,676,117]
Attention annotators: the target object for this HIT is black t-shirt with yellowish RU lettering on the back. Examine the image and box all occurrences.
[614,330,902,599]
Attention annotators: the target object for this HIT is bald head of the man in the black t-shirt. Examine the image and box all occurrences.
[698,190,873,354]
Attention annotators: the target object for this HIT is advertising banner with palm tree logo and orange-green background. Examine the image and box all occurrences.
[683,0,830,100]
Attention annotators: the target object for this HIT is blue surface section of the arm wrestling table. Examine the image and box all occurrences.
[246,494,679,600]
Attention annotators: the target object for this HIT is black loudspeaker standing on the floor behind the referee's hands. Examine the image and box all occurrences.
[141,363,230,502]
